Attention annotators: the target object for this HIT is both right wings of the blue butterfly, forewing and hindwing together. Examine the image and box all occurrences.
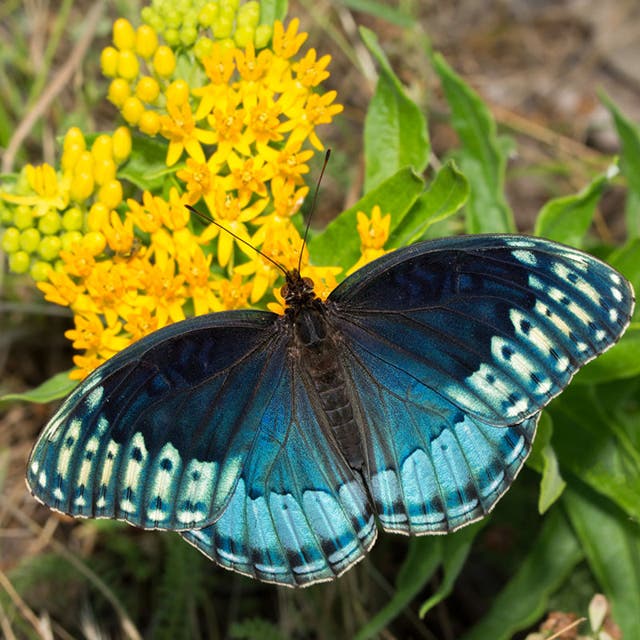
[329,236,633,533]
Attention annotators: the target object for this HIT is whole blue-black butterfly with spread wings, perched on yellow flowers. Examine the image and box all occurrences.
[27,235,634,587]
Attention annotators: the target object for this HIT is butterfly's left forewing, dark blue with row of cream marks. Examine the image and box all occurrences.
[27,311,286,529]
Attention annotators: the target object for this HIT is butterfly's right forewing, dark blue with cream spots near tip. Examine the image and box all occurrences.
[329,236,633,425]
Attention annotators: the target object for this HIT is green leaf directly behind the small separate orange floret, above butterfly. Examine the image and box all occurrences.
[309,168,424,269]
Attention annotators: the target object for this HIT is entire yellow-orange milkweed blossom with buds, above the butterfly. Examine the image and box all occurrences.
[0,0,380,379]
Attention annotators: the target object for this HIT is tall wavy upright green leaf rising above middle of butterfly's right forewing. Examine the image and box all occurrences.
[433,54,515,233]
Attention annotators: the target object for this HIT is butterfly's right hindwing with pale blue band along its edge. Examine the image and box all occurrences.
[336,328,539,535]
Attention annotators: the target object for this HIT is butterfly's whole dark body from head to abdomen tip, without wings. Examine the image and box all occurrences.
[282,270,364,469]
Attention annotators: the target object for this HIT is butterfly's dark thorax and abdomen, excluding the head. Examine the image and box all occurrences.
[294,305,364,469]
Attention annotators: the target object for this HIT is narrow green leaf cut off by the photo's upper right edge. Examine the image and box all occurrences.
[600,92,640,238]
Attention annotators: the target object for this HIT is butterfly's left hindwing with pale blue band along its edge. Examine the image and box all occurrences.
[181,351,377,586]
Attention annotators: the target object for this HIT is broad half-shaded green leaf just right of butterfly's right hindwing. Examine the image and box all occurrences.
[549,383,640,520]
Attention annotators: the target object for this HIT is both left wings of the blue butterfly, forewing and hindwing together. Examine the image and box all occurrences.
[27,311,376,586]
